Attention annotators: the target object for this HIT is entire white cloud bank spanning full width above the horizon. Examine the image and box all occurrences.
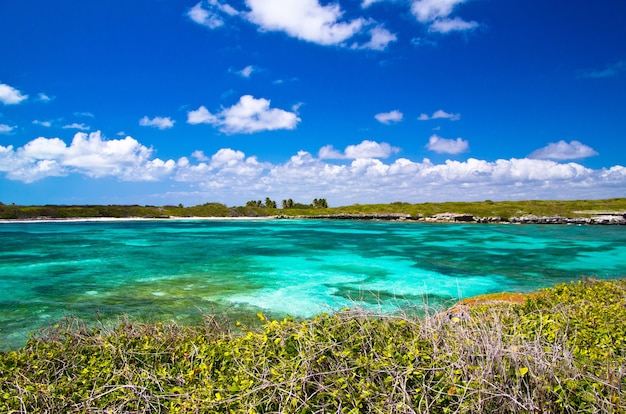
[0,136,626,205]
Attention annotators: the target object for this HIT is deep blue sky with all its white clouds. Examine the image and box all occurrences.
[0,0,626,206]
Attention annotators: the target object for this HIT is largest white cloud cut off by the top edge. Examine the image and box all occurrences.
[188,0,396,50]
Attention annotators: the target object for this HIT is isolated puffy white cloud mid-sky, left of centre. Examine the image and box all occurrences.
[187,95,300,134]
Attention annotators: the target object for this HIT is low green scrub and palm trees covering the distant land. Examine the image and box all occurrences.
[0,198,626,219]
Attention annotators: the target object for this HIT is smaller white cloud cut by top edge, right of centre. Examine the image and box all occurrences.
[411,0,478,33]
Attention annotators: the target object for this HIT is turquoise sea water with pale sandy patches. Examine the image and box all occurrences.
[0,220,626,349]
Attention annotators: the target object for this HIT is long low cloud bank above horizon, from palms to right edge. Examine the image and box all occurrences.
[175,150,626,205]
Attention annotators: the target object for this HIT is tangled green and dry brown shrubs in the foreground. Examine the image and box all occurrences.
[0,280,626,413]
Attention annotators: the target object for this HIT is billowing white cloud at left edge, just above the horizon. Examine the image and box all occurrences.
[0,131,175,183]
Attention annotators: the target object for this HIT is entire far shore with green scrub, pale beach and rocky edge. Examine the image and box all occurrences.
[0,197,626,224]
